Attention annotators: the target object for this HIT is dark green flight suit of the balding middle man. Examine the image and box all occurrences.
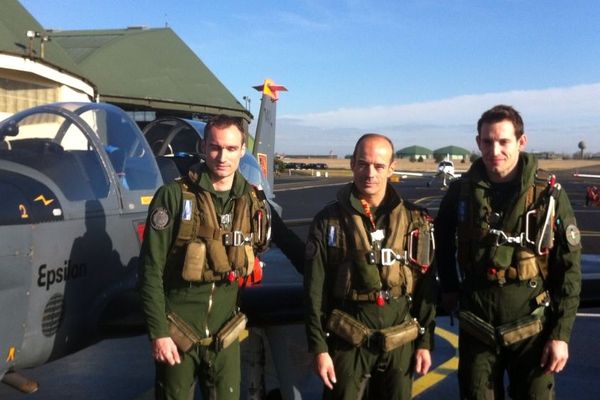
[304,184,435,399]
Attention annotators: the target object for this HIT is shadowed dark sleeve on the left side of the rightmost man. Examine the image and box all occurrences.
[435,181,460,293]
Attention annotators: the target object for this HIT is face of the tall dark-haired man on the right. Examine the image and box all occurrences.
[476,120,527,182]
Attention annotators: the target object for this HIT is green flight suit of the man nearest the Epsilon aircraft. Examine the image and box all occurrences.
[140,166,268,399]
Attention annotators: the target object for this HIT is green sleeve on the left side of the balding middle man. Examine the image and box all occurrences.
[304,213,328,354]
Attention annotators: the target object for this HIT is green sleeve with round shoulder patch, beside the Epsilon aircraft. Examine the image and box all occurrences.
[140,184,181,339]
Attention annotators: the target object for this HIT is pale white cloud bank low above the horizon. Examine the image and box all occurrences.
[276,83,600,155]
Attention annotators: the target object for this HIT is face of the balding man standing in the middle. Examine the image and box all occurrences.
[350,137,394,200]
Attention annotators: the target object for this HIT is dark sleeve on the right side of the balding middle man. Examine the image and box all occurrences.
[412,258,437,350]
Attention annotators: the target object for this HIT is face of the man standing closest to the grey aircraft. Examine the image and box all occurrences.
[204,125,246,180]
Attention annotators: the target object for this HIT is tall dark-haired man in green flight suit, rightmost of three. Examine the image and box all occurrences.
[436,105,581,399]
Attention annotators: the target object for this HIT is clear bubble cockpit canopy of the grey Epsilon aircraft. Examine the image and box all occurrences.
[0,103,160,201]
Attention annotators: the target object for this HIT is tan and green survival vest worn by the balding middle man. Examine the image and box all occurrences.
[326,185,434,302]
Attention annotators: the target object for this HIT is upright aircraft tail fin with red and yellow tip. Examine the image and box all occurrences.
[252,79,287,194]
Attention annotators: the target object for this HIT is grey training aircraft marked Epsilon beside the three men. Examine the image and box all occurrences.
[0,82,310,393]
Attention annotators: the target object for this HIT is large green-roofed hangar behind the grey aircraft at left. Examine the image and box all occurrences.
[0,0,252,130]
